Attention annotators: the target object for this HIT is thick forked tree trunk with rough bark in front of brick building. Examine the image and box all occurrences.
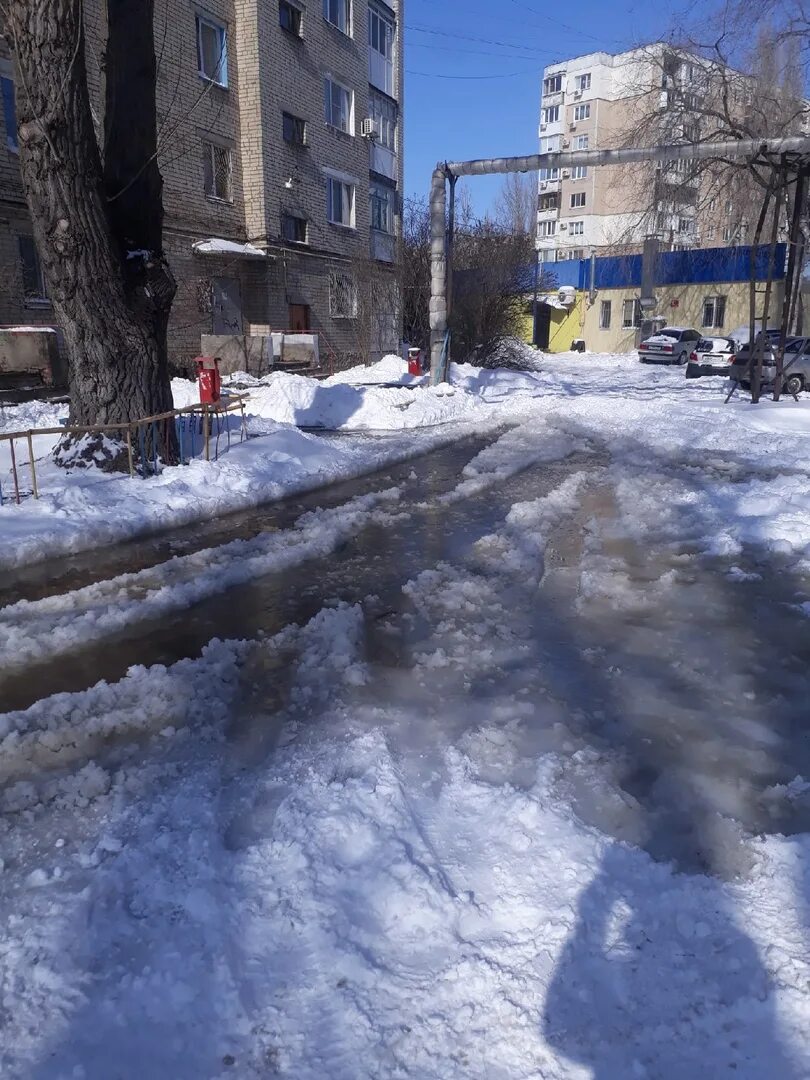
[5,0,175,447]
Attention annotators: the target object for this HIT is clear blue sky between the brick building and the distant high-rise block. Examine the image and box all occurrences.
[405,0,672,211]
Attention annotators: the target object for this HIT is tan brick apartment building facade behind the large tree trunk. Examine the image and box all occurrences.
[0,0,403,367]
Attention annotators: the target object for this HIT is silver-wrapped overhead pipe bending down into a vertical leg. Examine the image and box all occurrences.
[430,135,810,384]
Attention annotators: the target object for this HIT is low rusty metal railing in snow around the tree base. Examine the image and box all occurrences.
[0,394,247,507]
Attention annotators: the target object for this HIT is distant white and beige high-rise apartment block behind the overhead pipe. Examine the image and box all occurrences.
[537,44,745,261]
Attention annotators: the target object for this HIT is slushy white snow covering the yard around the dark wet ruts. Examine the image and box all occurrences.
[0,345,810,1080]
